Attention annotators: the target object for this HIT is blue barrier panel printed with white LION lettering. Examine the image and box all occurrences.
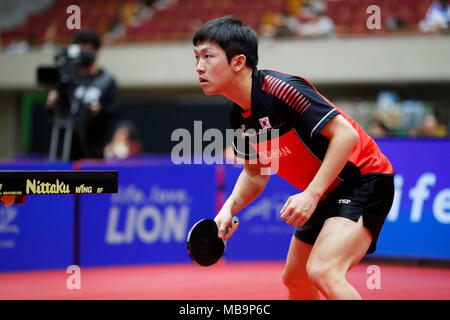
[80,161,216,266]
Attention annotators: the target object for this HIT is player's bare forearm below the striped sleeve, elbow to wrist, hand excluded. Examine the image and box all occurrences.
[305,129,358,199]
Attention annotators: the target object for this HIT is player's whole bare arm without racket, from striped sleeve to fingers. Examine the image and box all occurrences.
[280,115,359,226]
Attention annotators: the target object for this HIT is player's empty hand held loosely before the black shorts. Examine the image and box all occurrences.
[280,191,319,227]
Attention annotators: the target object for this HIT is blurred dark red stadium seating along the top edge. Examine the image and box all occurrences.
[0,0,433,46]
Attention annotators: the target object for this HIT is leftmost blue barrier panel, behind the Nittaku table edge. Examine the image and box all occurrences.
[0,162,74,271]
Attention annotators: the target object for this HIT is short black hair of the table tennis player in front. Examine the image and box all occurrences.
[192,16,258,69]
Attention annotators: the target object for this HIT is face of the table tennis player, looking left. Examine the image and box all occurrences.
[194,42,233,95]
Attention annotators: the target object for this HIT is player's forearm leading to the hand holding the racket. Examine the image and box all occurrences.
[223,169,269,215]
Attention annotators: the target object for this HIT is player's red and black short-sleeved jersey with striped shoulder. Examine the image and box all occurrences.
[231,69,394,194]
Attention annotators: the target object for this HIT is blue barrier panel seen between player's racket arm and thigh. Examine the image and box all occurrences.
[225,165,299,261]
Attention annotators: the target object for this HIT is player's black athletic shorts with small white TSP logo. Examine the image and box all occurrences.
[294,174,394,253]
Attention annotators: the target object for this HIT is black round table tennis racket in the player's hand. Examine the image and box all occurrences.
[187,217,239,267]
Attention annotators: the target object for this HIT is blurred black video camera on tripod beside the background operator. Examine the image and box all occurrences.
[37,44,95,161]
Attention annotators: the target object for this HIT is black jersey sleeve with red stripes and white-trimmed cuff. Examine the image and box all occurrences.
[271,76,339,137]
